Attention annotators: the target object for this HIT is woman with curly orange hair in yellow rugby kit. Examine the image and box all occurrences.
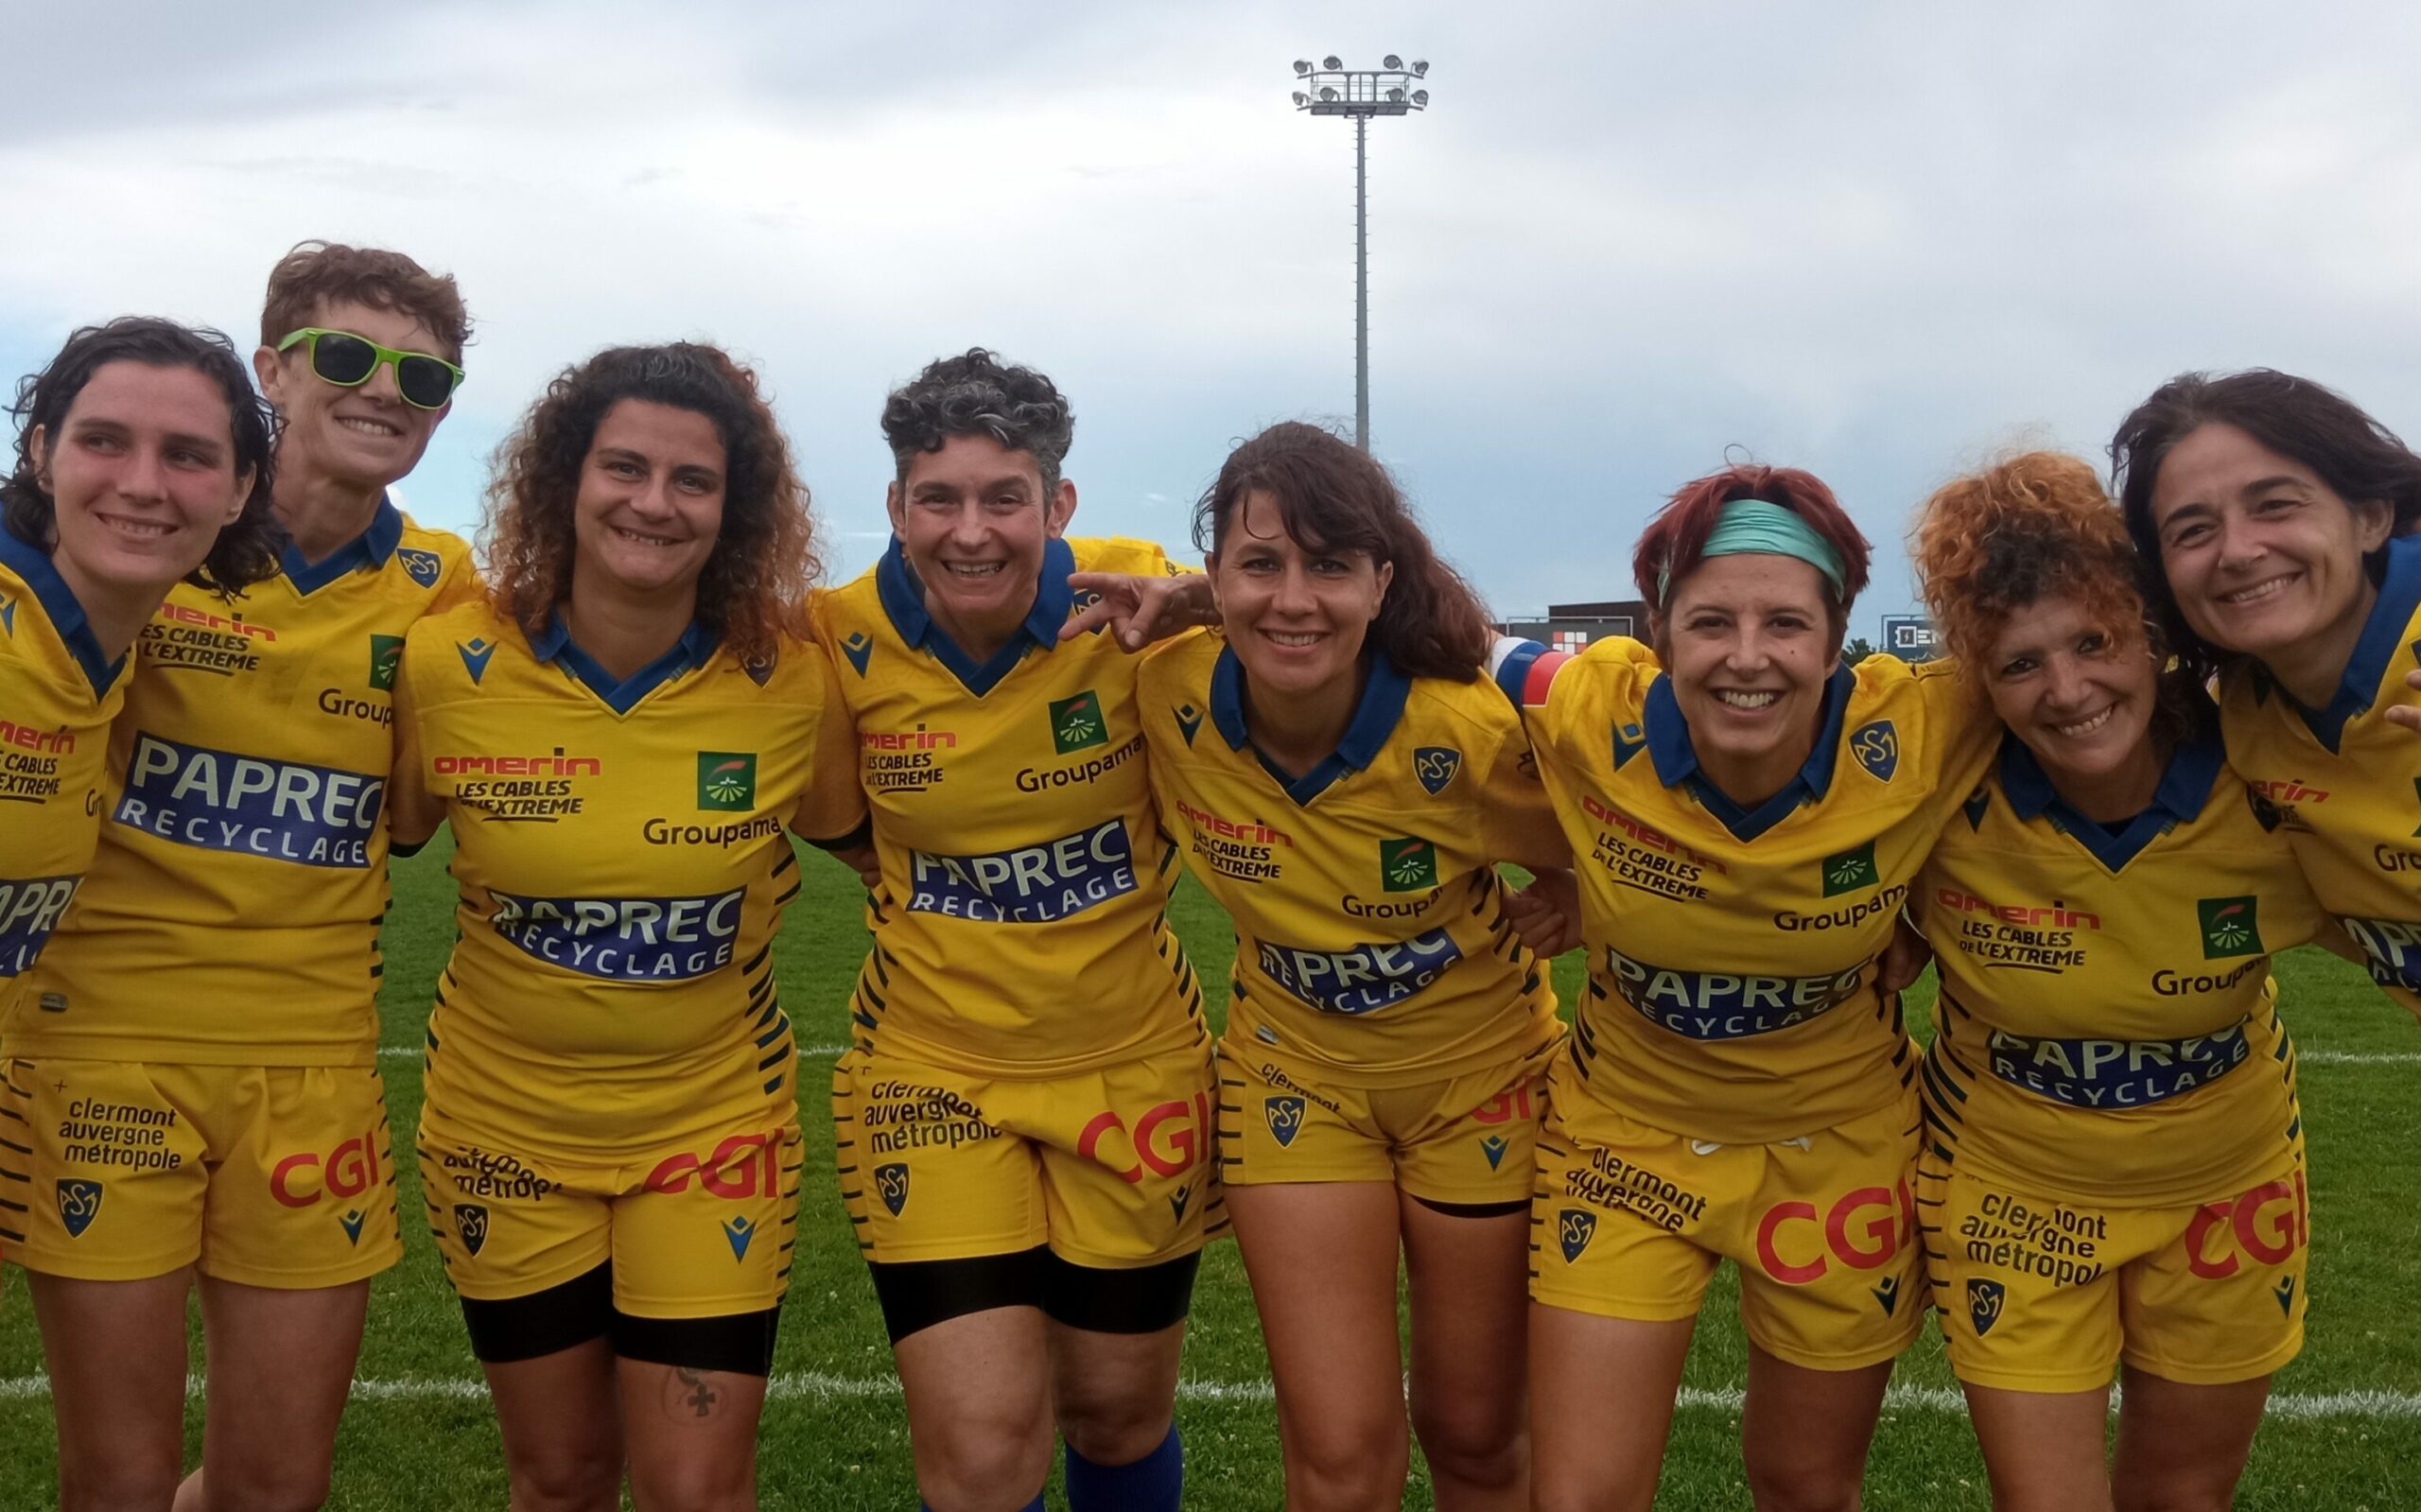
[1910,452,2322,1512]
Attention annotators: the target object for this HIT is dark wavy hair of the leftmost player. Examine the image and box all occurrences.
[0,315,286,598]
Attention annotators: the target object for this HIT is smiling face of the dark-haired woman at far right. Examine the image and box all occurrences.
[2152,424,2395,704]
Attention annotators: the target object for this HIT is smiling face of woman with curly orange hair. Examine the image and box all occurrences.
[1985,595,2160,818]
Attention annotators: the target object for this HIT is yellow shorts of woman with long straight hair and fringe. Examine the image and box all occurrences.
[1218,1040,1557,1205]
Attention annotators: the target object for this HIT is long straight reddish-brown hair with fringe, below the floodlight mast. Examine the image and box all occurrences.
[1193,421,1496,682]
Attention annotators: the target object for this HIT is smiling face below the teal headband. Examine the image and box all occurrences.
[1656,551,1840,803]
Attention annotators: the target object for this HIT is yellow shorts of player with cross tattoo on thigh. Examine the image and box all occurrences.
[419,1105,799,1318]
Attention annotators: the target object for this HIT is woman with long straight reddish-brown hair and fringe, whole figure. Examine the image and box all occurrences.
[1138,424,1571,1512]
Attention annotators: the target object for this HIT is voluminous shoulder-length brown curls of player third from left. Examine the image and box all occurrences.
[479,341,823,660]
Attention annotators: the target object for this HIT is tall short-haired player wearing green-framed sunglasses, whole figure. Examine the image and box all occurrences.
[12,242,470,1507]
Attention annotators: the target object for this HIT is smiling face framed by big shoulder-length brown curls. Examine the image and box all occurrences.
[571,399,726,602]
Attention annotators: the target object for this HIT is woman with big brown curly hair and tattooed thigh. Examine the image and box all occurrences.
[392,343,862,1509]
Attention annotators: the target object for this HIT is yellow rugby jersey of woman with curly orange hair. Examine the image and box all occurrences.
[1910,733,2322,1205]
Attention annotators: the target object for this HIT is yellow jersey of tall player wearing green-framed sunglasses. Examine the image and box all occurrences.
[12,501,477,1065]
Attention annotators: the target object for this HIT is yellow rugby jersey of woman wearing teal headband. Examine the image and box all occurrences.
[1499,638,1997,1144]
